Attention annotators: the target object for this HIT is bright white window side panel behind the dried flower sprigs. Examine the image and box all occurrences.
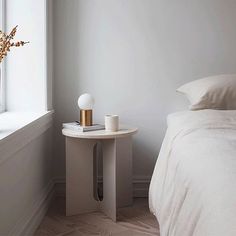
[6,0,47,111]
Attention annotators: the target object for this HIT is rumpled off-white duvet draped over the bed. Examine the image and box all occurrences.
[149,110,236,236]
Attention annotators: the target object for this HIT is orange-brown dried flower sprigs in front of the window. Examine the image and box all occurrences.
[0,26,29,63]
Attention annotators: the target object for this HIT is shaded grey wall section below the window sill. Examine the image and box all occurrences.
[0,128,52,235]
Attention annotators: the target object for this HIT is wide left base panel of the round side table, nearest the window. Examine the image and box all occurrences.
[66,137,99,216]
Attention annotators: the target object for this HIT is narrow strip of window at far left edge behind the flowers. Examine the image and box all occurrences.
[0,0,5,113]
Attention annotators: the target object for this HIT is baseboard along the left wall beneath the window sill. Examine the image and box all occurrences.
[9,180,55,236]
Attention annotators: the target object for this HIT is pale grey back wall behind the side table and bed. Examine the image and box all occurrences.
[54,0,236,179]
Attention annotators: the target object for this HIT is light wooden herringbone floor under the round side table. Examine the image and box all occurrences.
[35,198,159,236]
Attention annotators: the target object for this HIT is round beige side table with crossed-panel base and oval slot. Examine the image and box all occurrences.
[62,128,137,221]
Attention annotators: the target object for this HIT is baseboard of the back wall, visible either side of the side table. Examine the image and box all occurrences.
[54,176,151,198]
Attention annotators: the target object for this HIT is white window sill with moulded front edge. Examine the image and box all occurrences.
[0,111,53,164]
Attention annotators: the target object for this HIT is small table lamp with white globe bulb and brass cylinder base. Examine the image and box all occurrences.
[78,93,94,126]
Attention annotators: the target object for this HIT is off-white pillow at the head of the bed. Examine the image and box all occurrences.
[177,74,236,110]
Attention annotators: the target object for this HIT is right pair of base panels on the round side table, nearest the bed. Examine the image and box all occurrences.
[101,137,133,221]
